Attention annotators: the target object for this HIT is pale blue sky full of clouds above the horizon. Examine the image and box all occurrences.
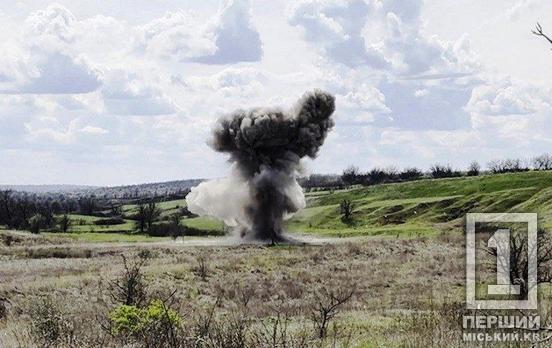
[0,0,552,185]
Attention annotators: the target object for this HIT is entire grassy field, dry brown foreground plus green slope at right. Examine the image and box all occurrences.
[0,172,552,348]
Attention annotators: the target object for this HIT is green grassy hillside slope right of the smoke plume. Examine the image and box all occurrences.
[287,171,552,236]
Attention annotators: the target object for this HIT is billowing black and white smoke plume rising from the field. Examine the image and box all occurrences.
[186,90,335,242]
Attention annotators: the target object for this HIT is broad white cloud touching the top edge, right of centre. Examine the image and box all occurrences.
[288,0,477,76]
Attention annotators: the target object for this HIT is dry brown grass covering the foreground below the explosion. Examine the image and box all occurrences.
[0,232,508,347]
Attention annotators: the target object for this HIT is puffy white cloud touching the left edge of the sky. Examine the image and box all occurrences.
[0,4,100,94]
